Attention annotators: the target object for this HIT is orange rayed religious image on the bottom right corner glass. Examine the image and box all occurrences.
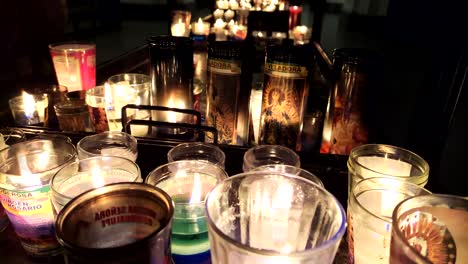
[400,211,458,264]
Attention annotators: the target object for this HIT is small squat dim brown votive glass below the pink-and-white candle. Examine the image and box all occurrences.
[54,100,94,132]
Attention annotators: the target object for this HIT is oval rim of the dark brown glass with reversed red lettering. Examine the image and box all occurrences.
[54,182,174,253]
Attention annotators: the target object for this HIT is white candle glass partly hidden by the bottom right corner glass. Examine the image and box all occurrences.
[348,177,430,264]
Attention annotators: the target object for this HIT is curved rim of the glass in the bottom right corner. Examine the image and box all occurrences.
[392,194,468,264]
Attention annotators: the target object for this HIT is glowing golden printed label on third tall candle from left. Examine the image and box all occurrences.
[259,63,308,149]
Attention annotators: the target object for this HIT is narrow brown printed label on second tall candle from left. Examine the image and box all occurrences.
[207,59,245,145]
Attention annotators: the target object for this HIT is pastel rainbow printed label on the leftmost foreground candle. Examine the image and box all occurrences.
[0,186,59,253]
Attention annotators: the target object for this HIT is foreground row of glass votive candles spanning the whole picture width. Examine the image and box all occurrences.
[0,129,468,263]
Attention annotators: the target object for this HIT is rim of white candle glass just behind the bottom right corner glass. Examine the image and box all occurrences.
[350,177,432,223]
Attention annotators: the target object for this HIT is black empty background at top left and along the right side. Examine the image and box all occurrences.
[0,0,468,196]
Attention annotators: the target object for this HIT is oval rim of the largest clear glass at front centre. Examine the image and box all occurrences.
[205,171,347,257]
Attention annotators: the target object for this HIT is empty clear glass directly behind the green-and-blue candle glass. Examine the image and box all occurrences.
[167,142,226,169]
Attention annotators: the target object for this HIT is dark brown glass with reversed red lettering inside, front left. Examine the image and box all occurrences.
[55,183,174,264]
